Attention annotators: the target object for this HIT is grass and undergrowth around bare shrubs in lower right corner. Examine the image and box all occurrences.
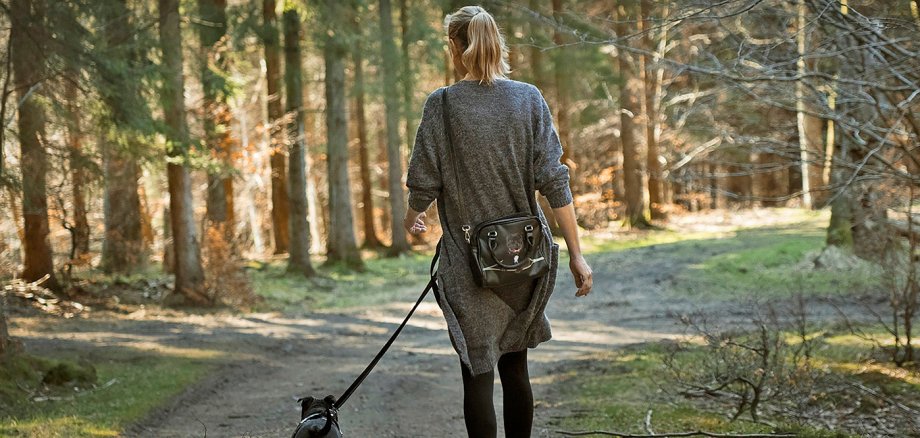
[556,327,920,438]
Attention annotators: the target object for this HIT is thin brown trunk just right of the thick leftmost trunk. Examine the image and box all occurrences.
[64,71,89,260]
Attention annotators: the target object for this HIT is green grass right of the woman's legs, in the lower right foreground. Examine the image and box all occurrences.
[557,331,920,438]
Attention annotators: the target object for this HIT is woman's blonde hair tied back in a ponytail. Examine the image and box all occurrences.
[444,6,511,85]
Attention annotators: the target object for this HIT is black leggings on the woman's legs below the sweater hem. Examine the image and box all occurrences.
[460,350,533,438]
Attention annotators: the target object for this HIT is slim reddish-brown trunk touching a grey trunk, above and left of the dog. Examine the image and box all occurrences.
[262,0,290,254]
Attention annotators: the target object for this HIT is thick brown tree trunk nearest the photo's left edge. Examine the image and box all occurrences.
[10,0,61,291]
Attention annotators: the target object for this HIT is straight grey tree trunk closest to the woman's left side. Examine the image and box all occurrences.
[379,0,409,255]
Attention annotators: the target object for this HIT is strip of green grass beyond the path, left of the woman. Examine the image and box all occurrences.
[251,253,432,311]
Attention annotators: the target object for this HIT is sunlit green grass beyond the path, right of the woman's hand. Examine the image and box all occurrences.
[582,211,882,299]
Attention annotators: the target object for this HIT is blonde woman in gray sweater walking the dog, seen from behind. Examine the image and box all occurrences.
[404,6,592,438]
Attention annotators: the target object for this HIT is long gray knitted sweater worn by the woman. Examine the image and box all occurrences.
[406,79,572,374]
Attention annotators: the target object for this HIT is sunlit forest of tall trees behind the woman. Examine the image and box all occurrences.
[0,0,920,436]
